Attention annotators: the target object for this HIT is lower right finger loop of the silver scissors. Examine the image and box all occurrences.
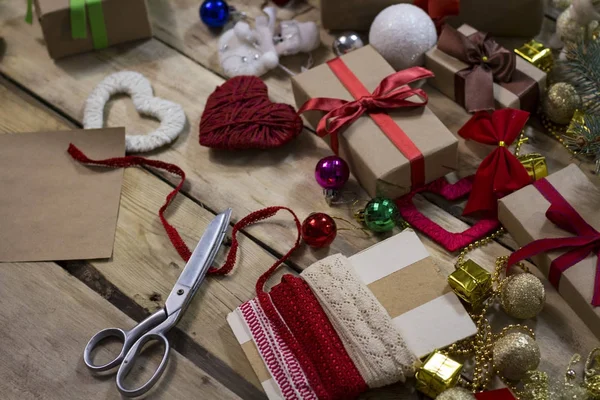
[117,313,179,397]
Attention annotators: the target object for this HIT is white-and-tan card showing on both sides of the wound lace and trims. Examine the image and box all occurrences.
[227,229,477,400]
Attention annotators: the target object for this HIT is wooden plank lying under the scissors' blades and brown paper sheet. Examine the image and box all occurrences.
[0,80,291,397]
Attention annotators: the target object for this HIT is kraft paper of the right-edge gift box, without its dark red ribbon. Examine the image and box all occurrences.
[498,164,600,338]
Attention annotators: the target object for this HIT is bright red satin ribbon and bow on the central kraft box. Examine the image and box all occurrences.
[298,58,433,188]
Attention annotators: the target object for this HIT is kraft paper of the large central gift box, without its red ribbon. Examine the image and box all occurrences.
[292,46,458,199]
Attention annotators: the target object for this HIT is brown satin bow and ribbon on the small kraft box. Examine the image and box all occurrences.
[438,26,517,112]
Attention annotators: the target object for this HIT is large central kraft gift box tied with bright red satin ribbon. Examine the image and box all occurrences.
[292,46,458,198]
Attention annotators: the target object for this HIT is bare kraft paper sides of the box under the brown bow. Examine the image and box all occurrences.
[425,25,546,112]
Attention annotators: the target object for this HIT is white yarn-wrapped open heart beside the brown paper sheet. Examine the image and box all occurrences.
[83,71,185,153]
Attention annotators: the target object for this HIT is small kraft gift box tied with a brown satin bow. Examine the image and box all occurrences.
[425,25,546,112]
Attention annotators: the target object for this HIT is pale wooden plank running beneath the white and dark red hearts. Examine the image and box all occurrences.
[0,0,376,266]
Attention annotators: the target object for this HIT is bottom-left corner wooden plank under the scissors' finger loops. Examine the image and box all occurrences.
[0,263,239,400]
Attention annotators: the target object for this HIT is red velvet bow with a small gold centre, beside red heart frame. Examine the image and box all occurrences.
[458,108,531,217]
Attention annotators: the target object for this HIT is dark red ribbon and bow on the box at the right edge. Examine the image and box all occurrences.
[507,178,600,307]
